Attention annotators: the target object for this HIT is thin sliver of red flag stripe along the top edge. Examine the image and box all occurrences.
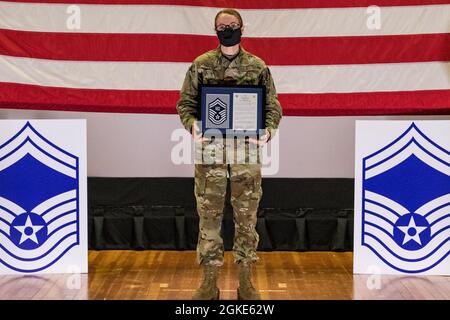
[4,0,450,9]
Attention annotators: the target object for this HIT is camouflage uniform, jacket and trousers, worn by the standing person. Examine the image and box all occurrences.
[177,46,282,266]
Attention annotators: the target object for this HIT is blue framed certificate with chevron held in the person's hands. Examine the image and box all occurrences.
[199,85,266,137]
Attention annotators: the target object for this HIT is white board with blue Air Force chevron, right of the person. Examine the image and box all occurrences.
[354,120,450,275]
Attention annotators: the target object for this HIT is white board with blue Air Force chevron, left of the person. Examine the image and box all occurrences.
[0,120,88,274]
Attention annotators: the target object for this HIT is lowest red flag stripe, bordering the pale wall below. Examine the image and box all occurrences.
[0,83,450,116]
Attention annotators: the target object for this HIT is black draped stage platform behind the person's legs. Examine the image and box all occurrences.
[88,177,354,251]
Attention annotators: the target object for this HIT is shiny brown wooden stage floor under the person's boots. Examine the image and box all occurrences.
[0,250,450,300]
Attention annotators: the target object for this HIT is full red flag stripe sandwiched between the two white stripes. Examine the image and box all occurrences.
[0,29,450,65]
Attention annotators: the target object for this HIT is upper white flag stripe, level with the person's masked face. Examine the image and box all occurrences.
[0,2,450,37]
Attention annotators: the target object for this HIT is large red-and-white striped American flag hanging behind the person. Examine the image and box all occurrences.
[0,0,450,116]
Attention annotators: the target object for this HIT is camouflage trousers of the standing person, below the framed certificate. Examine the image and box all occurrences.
[194,142,262,266]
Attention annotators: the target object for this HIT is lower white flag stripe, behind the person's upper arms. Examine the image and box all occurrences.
[0,55,450,93]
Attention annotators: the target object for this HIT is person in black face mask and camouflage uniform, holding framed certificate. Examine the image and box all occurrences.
[177,9,282,300]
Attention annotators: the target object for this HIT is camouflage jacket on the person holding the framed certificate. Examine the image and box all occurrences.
[177,45,282,138]
